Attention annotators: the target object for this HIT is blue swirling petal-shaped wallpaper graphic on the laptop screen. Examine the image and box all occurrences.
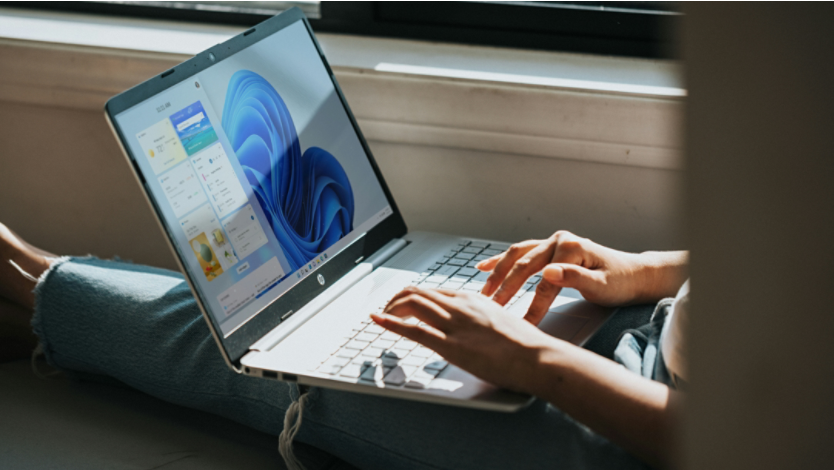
[222,70,354,272]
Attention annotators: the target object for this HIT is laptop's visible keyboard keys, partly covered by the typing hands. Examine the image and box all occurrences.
[316,241,541,389]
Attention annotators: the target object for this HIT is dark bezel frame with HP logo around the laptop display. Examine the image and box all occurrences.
[104,8,407,368]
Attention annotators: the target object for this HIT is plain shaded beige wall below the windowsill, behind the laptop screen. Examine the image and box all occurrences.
[0,103,681,269]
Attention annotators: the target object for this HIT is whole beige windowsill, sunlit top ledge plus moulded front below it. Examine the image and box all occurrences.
[0,8,686,170]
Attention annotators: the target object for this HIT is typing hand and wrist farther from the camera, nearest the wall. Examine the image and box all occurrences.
[477,231,686,325]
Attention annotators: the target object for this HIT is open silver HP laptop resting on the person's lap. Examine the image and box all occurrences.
[105,8,611,411]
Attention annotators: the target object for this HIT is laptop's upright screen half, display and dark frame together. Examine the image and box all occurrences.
[105,8,406,366]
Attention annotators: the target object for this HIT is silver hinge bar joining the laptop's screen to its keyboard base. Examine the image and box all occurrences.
[249,238,408,352]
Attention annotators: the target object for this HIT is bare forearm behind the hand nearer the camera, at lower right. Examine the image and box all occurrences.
[530,339,680,466]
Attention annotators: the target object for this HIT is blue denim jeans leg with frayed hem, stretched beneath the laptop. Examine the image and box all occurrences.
[33,258,645,469]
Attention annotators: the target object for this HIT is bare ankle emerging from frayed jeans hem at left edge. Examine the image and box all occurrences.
[0,223,51,310]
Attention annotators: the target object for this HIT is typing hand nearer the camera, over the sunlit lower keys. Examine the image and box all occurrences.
[371,287,554,393]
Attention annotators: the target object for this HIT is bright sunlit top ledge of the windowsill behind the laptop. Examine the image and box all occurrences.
[0,8,686,97]
